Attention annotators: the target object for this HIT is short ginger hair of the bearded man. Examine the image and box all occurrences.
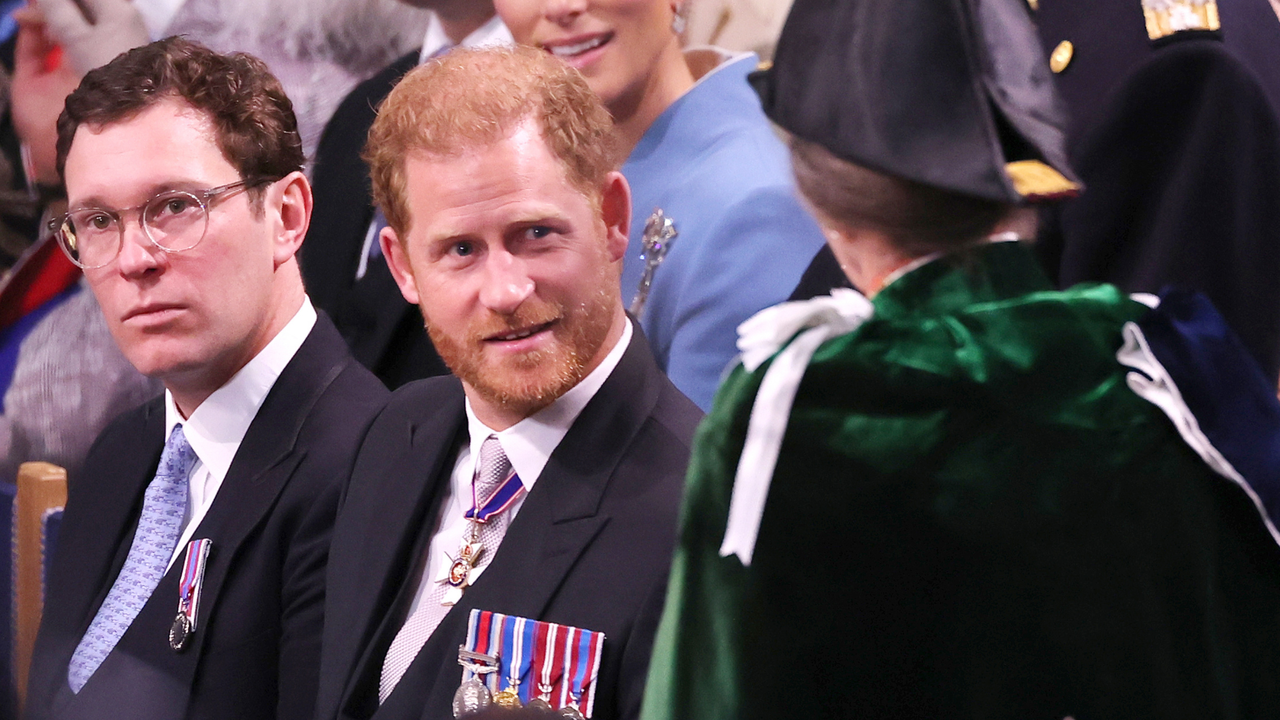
[365,47,618,240]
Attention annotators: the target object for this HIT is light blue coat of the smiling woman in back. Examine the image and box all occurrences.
[622,54,823,410]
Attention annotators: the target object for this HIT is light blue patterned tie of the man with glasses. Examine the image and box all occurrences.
[67,425,196,693]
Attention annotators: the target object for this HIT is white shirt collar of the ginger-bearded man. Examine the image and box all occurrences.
[466,320,632,491]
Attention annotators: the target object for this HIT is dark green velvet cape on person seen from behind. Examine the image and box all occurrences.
[643,243,1280,720]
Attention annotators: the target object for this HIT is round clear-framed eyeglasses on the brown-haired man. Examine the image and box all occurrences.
[49,181,262,270]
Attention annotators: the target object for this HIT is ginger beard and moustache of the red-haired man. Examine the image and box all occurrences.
[421,233,621,416]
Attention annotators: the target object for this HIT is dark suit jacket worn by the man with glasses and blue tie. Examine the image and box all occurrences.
[26,314,388,720]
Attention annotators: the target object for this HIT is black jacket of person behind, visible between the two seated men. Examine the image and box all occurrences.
[300,51,448,388]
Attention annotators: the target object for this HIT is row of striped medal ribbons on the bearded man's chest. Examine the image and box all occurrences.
[462,610,604,717]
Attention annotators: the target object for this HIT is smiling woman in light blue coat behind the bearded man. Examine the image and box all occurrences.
[494,0,822,409]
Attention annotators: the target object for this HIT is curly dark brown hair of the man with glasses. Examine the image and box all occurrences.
[58,37,305,191]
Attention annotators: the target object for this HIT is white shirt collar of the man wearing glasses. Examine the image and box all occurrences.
[164,297,316,478]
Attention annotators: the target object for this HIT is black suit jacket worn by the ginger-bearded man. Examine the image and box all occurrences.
[316,329,701,720]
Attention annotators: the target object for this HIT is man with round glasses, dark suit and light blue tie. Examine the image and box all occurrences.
[27,38,387,720]
